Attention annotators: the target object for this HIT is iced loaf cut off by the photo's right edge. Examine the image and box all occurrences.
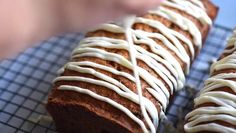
[184,31,236,133]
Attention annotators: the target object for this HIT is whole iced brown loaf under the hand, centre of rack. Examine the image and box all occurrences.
[46,0,217,133]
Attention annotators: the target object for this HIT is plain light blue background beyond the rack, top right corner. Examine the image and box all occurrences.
[212,0,236,28]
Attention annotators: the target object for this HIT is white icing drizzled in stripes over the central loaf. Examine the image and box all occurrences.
[55,0,211,133]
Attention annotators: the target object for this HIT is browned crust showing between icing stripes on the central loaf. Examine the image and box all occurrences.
[48,0,218,132]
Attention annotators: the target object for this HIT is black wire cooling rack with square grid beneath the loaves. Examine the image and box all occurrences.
[0,25,232,133]
